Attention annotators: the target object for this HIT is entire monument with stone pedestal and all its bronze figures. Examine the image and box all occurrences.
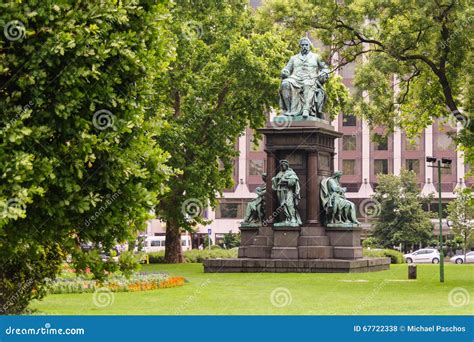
[204,38,390,272]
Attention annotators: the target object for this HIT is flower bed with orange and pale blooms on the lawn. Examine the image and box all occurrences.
[48,273,185,294]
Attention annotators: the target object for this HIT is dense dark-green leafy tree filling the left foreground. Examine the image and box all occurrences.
[0,1,173,313]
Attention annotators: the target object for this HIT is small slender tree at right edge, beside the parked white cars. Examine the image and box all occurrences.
[447,189,474,262]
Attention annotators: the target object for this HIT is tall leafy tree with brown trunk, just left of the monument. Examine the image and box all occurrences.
[157,0,289,262]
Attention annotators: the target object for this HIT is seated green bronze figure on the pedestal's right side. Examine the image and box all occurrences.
[320,171,360,225]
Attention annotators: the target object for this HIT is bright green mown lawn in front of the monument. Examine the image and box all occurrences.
[31,264,474,315]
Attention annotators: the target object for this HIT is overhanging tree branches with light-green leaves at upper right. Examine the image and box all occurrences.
[261,0,474,160]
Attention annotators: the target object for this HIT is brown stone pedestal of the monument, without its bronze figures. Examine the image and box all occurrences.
[210,118,390,272]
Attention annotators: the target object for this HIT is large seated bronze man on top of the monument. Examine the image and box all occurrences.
[280,37,329,119]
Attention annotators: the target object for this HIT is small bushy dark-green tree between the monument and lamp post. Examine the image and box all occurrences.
[372,171,433,249]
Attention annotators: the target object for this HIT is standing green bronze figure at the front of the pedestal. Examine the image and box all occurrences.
[272,160,302,227]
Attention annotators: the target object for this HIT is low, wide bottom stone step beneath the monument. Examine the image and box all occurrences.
[203,258,390,273]
